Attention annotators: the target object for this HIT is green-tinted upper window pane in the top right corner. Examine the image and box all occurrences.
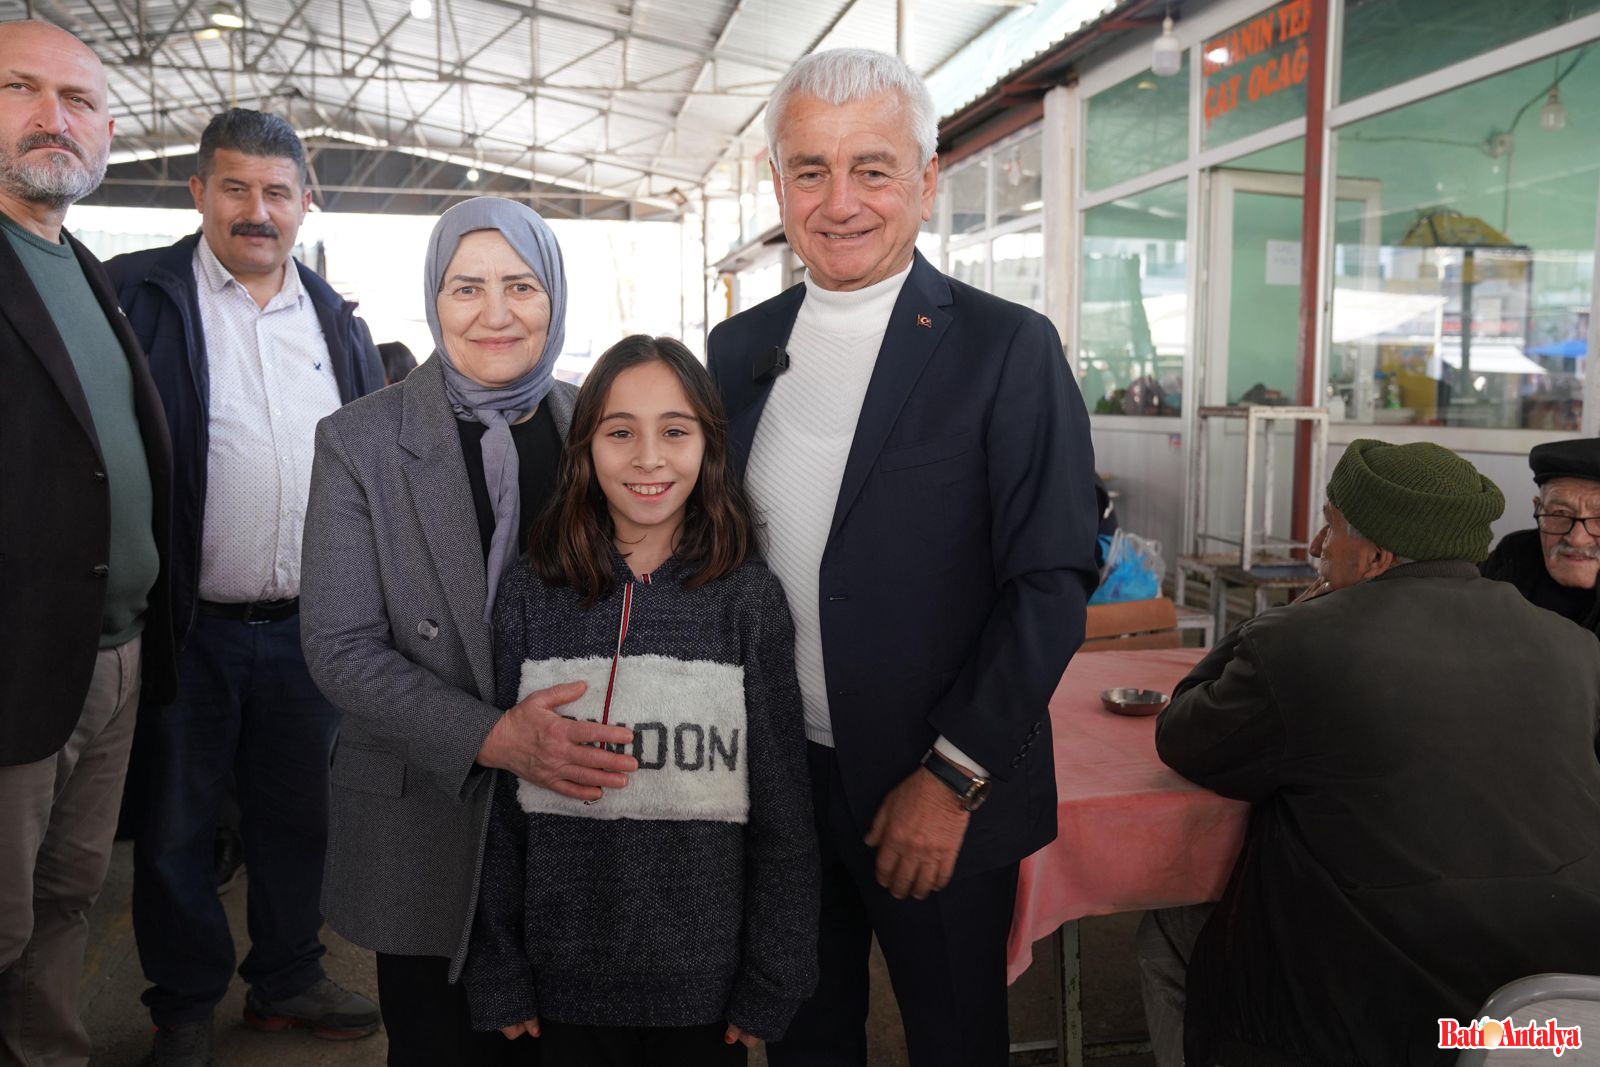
[1339,0,1600,101]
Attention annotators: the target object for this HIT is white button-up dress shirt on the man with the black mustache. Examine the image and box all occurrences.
[194,237,339,603]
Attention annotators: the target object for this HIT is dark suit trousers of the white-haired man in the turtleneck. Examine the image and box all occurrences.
[766,744,1018,1067]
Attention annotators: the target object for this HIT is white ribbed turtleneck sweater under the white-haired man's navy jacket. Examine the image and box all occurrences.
[747,266,984,774]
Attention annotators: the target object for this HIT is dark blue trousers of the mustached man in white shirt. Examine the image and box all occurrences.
[133,613,339,1025]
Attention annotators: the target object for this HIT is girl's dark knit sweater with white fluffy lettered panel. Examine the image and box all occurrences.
[462,557,819,1040]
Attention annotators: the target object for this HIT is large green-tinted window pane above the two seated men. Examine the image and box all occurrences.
[1328,50,1600,432]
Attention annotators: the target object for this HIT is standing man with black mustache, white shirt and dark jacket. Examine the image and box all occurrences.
[107,107,384,1067]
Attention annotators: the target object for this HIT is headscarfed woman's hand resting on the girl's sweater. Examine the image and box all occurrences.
[478,681,638,800]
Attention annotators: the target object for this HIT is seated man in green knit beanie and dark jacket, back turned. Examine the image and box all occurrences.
[1139,440,1600,1067]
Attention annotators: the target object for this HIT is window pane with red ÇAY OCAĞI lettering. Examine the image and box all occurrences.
[1200,0,1312,149]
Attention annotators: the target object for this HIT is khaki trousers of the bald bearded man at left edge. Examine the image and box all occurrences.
[0,637,139,1067]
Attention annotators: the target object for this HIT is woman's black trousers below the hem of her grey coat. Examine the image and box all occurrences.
[378,952,541,1067]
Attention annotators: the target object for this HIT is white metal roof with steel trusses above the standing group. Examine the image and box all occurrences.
[40,0,1024,214]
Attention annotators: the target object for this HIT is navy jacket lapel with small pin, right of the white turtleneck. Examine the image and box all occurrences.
[827,253,950,542]
